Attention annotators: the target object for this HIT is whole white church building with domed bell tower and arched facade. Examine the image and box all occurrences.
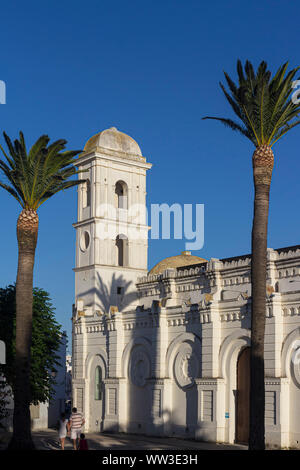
[72,128,300,448]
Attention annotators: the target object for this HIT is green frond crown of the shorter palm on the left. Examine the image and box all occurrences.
[0,132,84,210]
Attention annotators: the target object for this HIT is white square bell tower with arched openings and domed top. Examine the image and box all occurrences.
[74,127,152,316]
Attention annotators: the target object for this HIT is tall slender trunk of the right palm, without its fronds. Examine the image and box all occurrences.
[249,146,274,450]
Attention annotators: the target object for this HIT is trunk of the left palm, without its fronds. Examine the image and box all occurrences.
[8,209,38,450]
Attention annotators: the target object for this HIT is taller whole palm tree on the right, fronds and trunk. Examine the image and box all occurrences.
[203,60,300,449]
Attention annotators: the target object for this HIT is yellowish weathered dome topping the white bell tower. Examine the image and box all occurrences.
[84,127,142,156]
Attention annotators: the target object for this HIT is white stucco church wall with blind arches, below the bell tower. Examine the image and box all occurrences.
[73,249,300,447]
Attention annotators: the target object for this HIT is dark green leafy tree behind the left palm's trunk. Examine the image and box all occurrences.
[0,285,62,404]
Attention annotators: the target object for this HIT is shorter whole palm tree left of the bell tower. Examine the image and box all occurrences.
[0,132,82,449]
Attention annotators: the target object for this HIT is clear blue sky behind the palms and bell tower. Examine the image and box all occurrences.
[0,0,300,342]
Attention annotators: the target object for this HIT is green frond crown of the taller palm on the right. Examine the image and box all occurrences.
[203,60,300,147]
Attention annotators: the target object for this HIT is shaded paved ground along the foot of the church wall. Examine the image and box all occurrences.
[2,429,247,450]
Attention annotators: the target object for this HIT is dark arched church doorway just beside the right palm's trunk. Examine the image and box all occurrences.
[236,348,250,444]
